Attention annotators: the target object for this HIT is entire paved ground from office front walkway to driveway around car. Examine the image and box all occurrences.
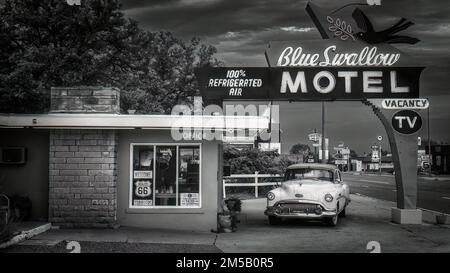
[3,192,450,253]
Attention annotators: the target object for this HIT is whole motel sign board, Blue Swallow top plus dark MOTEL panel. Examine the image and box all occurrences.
[196,39,423,101]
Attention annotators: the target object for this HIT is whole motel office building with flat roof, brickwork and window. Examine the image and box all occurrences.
[0,87,268,231]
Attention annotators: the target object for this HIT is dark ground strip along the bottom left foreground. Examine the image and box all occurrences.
[0,241,221,253]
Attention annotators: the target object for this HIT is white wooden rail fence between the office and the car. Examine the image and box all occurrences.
[222,172,282,198]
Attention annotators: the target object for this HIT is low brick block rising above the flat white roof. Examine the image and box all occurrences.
[50,86,120,114]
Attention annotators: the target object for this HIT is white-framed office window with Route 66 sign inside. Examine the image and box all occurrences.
[130,144,201,208]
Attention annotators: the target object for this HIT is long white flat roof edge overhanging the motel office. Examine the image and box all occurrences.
[0,113,269,131]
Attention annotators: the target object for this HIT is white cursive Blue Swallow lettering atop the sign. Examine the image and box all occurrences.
[277,45,400,66]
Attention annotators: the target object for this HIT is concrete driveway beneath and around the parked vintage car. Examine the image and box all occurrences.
[216,195,450,253]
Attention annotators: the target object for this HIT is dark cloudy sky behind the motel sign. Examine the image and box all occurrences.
[122,0,450,153]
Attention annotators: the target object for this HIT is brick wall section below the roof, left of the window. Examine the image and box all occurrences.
[49,130,118,228]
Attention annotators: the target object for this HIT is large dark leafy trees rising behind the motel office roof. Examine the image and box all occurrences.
[0,0,221,113]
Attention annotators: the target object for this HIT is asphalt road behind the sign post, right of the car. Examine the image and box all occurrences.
[344,173,450,213]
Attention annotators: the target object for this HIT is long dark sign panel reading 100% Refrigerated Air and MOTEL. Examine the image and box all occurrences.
[197,67,422,101]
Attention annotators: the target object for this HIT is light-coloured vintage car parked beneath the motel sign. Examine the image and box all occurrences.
[264,163,350,226]
